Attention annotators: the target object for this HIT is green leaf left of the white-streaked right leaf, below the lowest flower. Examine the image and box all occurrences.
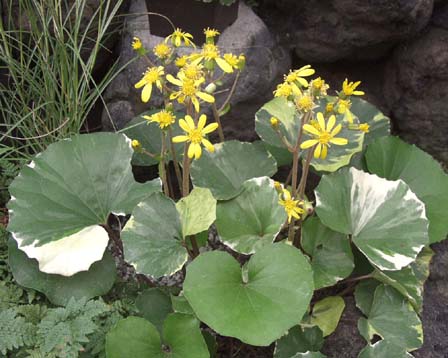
[302,217,354,289]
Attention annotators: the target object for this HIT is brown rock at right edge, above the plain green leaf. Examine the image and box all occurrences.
[384,26,448,164]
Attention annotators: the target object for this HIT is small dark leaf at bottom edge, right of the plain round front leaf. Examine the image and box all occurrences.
[274,325,324,358]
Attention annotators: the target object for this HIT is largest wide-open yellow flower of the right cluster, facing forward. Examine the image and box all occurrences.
[300,112,348,159]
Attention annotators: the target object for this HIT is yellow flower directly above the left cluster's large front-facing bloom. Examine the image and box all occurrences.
[166,74,215,112]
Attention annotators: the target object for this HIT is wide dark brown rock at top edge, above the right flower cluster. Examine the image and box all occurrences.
[264,0,433,63]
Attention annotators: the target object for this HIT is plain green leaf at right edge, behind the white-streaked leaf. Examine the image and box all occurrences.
[366,137,448,244]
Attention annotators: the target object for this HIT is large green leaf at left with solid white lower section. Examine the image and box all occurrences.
[8,133,160,276]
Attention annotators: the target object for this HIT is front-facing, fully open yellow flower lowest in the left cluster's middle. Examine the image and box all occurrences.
[173,114,218,159]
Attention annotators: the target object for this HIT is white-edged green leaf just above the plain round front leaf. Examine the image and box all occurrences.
[216,177,286,254]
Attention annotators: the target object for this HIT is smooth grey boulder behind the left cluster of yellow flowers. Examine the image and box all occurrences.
[102,0,290,134]
